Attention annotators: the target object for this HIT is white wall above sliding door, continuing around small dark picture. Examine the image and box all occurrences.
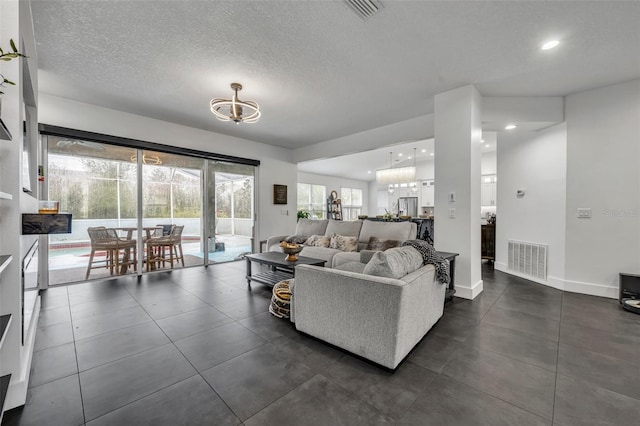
[38,93,297,240]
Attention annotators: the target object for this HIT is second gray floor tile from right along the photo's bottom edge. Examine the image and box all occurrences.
[396,375,551,426]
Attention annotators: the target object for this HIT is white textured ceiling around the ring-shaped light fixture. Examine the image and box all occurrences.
[32,0,640,156]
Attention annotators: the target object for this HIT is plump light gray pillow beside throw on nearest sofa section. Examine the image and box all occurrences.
[362,246,422,279]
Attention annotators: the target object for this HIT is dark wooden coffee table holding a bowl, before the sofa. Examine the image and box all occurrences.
[244,251,327,289]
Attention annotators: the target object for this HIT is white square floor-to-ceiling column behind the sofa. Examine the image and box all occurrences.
[434,85,482,299]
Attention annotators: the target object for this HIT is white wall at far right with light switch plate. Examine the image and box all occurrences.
[565,80,640,297]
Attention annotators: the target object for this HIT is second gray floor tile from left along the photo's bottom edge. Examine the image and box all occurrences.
[87,376,240,426]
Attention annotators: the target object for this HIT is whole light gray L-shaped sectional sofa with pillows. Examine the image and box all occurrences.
[267,219,446,369]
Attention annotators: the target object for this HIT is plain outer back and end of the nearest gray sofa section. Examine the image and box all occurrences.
[294,265,444,368]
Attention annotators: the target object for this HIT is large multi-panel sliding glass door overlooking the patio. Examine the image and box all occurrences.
[43,135,256,285]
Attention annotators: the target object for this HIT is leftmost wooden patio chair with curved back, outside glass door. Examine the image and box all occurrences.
[85,226,138,280]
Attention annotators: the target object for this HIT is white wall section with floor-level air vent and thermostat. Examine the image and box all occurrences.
[492,123,567,288]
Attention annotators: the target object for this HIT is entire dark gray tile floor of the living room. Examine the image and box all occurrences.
[2,262,640,426]
